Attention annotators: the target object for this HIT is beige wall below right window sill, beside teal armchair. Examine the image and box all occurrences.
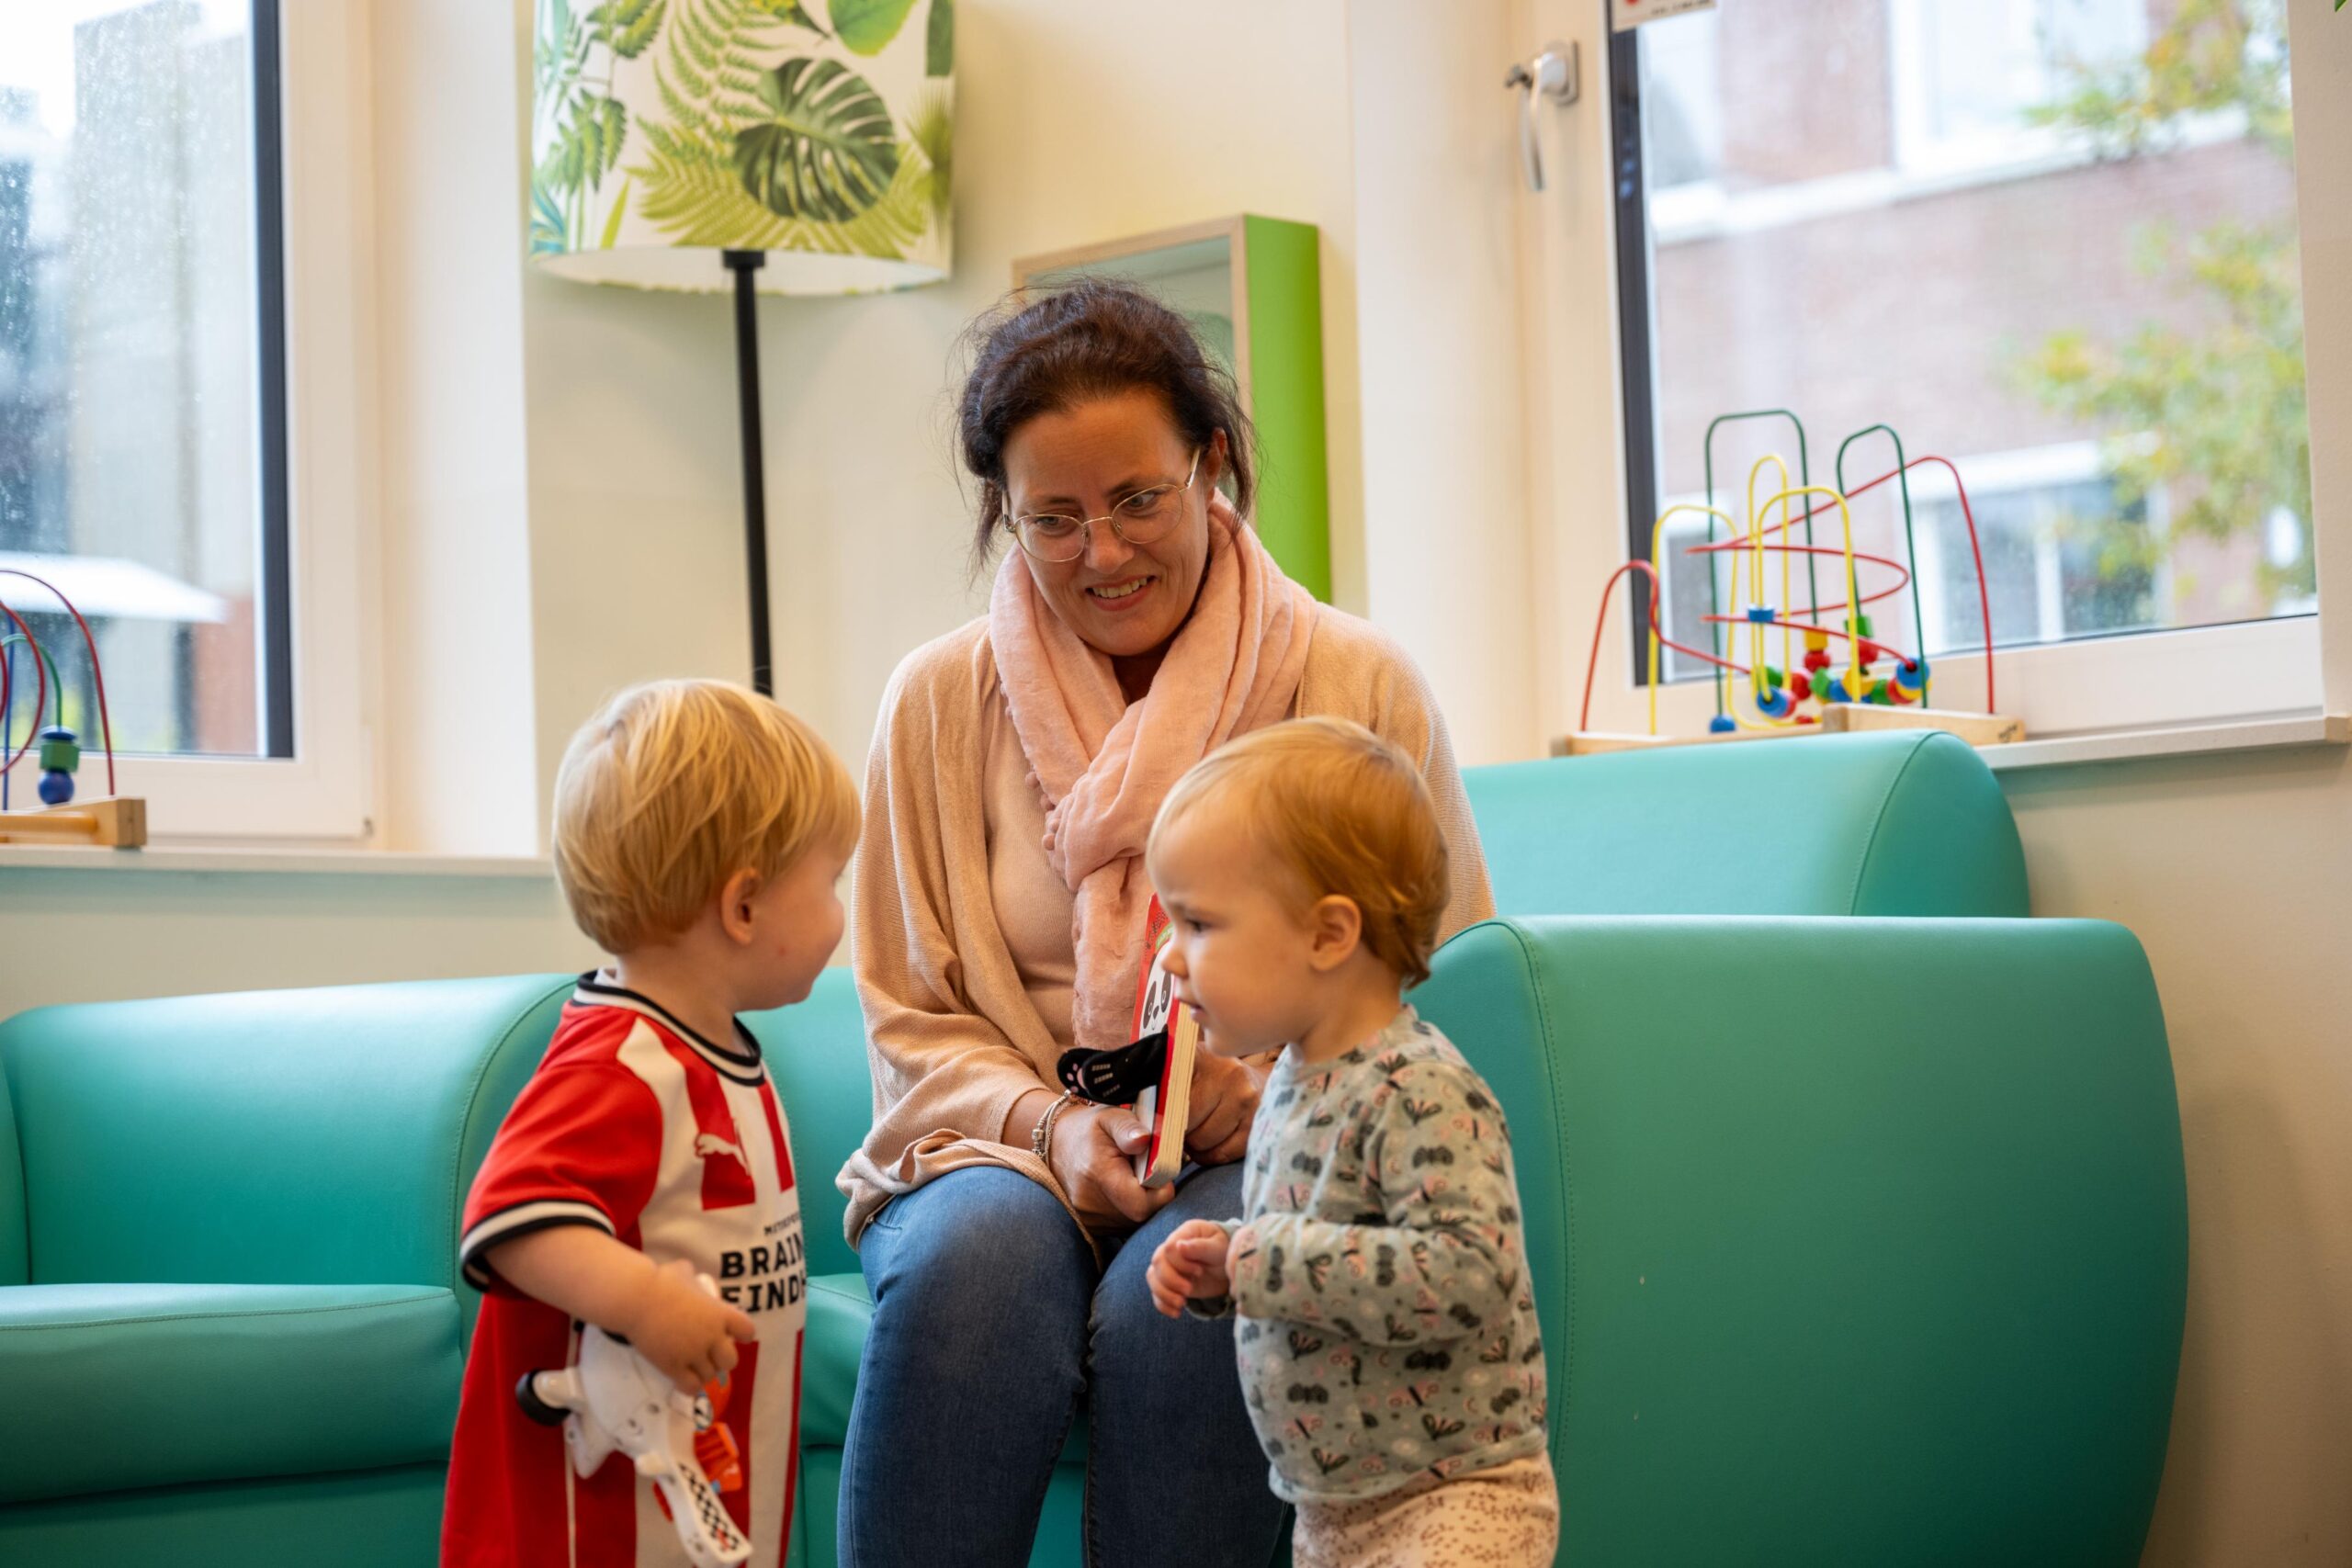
[2002,748,2352,1568]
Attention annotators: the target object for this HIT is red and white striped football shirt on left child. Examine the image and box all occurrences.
[442,976,809,1568]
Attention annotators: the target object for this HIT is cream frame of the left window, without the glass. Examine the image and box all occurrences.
[83,0,374,844]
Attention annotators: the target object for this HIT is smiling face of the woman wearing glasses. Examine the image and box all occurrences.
[1004,392,1226,659]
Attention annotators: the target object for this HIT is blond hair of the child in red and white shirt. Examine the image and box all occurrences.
[555,680,858,952]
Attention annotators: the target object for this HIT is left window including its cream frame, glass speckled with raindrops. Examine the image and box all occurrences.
[0,0,371,841]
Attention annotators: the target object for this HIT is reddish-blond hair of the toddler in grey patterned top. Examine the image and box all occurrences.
[1152,719,1449,985]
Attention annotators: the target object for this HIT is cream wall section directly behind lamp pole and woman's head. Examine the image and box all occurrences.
[522,0,1364,799]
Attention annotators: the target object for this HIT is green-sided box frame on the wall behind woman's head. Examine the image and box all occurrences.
[1013,214,1331,600]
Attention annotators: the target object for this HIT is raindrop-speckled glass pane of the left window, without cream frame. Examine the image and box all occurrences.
[0,0,294,773]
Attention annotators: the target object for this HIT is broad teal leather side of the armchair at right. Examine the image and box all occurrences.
[1414,919,2188,1565]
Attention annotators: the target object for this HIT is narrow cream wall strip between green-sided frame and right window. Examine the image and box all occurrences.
[1348,0,1543,761]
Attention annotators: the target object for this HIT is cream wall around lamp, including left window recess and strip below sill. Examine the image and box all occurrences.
[0,0,1366,1016]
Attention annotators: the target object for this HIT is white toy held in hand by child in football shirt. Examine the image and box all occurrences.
[515,1274,751,1568]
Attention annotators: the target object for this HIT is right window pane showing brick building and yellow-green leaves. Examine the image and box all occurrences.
[1611,0,2317,728]
